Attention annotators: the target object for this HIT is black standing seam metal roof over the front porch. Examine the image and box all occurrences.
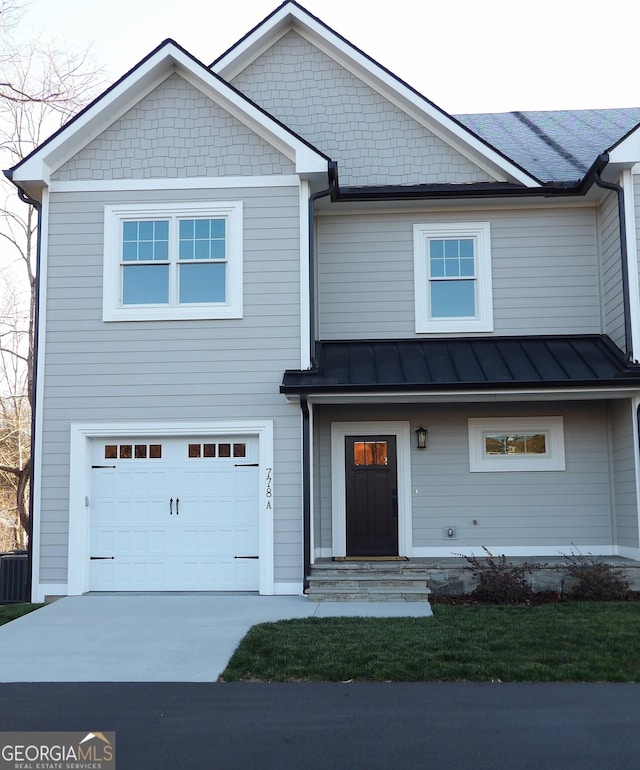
[280,335,640,393]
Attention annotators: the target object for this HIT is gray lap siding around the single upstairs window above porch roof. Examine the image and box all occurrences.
[318,207,602,339]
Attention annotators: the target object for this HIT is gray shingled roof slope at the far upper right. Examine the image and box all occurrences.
[456,107,640,182]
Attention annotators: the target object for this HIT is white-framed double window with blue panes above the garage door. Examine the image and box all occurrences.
[103,202,242,321]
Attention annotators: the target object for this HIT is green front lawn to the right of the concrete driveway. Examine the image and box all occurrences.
[222,602,640,682]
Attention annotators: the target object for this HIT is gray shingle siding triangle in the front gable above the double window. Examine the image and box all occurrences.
[52,74,293,181]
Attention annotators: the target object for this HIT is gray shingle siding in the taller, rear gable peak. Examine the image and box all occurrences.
[232,31,493,185]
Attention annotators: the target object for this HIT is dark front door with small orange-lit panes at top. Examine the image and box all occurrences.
[345,436,398,556]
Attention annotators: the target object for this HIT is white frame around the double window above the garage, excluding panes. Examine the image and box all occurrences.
[102,201,243,321]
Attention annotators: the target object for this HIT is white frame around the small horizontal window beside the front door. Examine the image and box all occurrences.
[468,416,566,473]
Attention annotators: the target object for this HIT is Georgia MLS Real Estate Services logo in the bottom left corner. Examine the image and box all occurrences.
[0,732,116,770]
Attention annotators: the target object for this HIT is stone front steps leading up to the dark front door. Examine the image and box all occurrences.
[307,560,431,602]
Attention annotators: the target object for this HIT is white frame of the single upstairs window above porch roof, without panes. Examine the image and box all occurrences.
[413,222,493,334]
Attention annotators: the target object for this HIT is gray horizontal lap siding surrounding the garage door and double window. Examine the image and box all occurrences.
[41,187,302,582]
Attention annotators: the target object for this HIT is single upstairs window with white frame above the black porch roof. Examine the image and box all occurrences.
[413,222,493,334]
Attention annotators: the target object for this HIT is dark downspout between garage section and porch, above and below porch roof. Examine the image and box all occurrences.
[300,165,338,593]
